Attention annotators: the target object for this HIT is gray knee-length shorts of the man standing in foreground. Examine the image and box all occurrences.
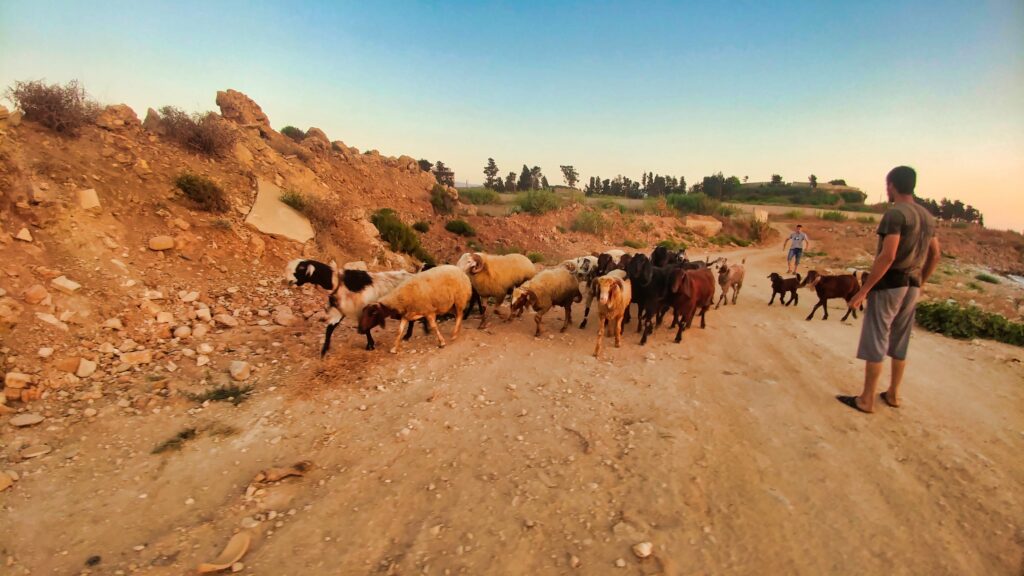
[857,286,921,362]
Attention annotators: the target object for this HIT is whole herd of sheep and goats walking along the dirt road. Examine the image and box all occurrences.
[286,246,866,358]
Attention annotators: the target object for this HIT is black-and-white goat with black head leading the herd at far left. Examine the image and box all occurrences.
[285,258,419,358]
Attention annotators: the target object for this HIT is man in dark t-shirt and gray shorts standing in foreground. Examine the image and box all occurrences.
[837,166,941,413]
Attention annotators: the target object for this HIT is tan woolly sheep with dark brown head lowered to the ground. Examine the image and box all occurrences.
[359,265,473,354]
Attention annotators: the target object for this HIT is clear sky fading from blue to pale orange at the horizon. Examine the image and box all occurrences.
[0,0,1024,231]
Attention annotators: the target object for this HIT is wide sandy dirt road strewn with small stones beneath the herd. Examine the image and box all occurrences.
[0,239,1024,576]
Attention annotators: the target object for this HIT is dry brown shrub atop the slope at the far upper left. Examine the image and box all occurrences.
[7,80,99,136]
